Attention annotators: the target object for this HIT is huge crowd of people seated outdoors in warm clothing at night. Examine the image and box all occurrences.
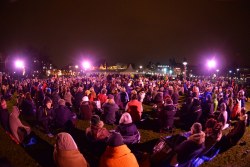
[0,74,249,167]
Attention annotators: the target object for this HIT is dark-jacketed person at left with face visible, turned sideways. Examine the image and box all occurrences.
[37,97,54,137]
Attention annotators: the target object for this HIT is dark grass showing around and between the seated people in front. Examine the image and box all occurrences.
[0,99,250,167]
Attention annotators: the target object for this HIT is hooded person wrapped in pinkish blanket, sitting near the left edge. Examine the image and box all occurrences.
[9,106,31,144]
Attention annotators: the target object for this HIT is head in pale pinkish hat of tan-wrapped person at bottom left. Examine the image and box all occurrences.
[55,132,78,151]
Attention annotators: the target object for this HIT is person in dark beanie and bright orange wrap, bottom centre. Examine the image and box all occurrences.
[99,132,139,167]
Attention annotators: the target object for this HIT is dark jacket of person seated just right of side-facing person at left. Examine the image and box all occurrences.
[54,105,73,128]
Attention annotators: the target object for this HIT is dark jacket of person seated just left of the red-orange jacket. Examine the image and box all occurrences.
[102,103,119,124]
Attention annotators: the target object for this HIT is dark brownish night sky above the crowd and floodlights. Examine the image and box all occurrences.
[0,0,250,66]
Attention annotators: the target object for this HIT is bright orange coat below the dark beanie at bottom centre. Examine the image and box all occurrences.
[100,144,139,167]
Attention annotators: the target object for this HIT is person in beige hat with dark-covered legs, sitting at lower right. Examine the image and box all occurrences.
[170,122,205,166]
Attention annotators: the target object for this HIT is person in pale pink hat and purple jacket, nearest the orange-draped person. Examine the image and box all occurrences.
[115,112,141,144]
